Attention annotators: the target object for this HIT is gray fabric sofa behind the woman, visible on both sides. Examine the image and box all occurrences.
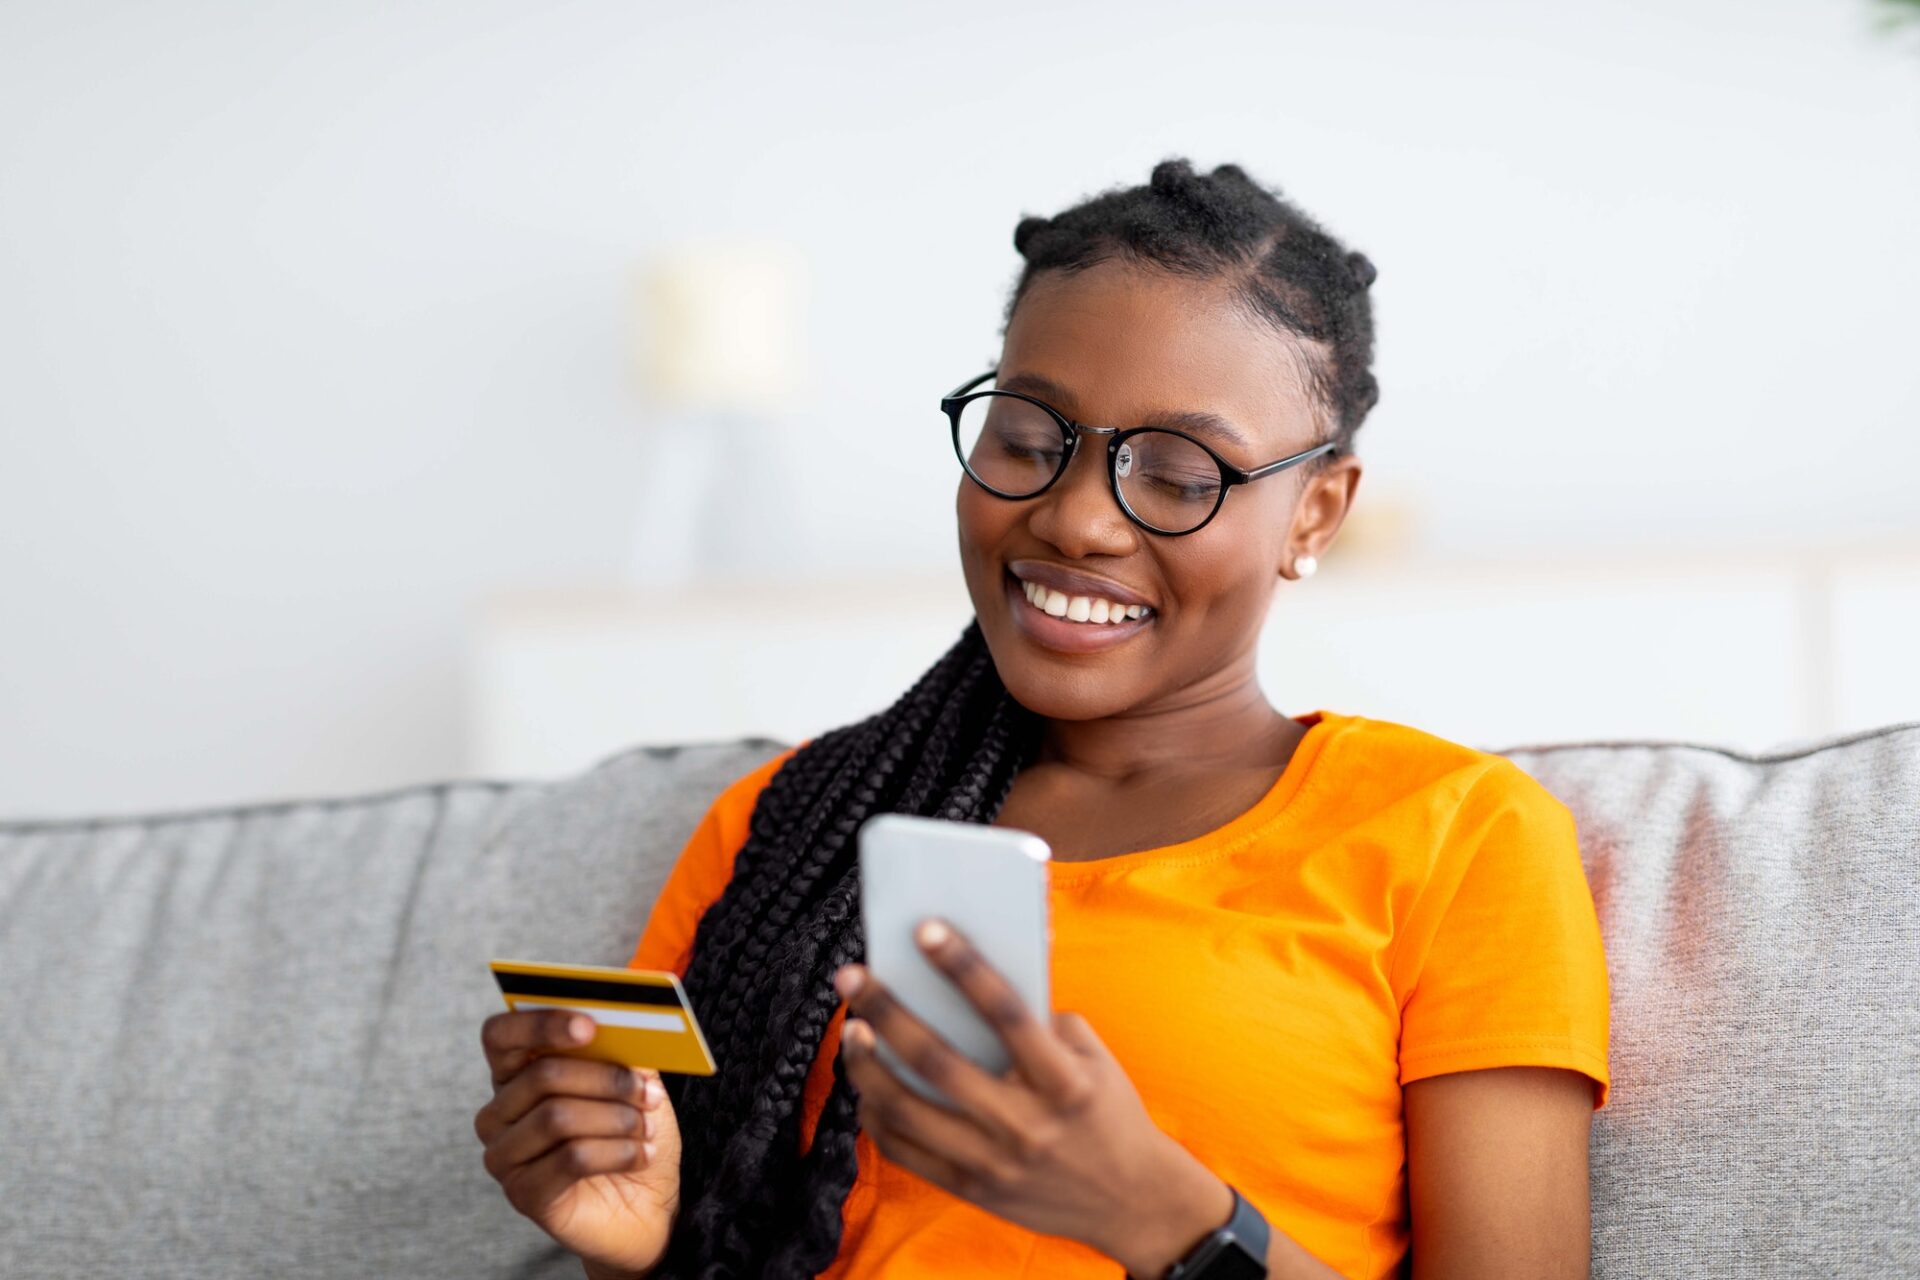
[0,723,1920,1280]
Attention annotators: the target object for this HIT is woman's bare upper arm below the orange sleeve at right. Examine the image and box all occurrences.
[1402,1067,1594,1280]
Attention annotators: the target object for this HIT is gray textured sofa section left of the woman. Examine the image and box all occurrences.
[0,743,778,1280]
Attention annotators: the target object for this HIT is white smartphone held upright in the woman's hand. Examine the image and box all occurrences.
[860,814,1052,1105]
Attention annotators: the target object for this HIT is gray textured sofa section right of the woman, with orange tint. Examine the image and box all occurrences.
[1500,723,1920,1280]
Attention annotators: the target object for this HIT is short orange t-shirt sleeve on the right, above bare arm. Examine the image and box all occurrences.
[1394,760,1611,1111]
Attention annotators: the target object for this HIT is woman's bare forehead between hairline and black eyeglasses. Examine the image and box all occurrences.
[995,261,1315,447]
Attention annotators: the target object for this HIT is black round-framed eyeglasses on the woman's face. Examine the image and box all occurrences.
[941,370,1340,537]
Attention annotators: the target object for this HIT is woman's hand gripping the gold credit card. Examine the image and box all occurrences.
[474,1009,680,1274]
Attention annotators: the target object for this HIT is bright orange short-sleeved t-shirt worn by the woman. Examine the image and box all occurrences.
[632,710,1609,1280]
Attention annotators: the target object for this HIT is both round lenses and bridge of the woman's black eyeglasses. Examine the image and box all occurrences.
[956,395,1221,533]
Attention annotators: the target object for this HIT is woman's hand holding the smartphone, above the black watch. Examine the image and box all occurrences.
[833,921,1233,1276]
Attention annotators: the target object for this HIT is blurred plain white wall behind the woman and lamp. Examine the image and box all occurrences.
[0,0,1920,816]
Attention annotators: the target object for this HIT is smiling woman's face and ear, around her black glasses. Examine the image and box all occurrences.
[956,259,1359,720]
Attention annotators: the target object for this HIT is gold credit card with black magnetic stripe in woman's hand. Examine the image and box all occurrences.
[488,960,714,1075]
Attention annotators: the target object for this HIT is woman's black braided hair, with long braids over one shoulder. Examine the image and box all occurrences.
[655,159,1379,1280]
